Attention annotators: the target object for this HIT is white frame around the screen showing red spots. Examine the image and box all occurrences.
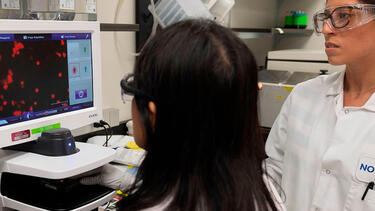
[0,20,102,148]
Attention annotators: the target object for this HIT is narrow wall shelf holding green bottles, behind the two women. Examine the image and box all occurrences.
[232,28,314,39]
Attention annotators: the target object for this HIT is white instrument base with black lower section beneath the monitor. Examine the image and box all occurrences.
[0,129,116,211]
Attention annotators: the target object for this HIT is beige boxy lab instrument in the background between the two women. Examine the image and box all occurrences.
[259,49,345,128]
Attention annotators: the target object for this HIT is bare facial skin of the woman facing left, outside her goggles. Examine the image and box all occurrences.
[322,0,375,65]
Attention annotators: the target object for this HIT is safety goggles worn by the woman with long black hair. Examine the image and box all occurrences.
[120,73,154,103]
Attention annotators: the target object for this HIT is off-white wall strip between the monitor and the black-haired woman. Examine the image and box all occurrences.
[97,0,135,121]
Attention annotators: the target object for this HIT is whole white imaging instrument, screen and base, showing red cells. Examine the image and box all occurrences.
[0,20,116,210]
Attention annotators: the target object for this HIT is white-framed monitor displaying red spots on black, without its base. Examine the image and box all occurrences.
[0,20,102,147]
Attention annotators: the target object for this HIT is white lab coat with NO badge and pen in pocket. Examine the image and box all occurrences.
[266,71,375,211]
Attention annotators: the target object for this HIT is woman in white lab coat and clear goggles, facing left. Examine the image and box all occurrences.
[266,0,375,211]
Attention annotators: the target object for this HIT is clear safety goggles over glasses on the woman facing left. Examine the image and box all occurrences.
[314,4,375,34]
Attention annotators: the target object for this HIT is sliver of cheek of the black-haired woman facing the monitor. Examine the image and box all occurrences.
[132,98,146,148]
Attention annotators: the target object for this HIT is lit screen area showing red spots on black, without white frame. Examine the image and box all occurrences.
[0,33,93,127]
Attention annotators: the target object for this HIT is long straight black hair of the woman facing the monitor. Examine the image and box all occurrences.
[118,20,276,211]
